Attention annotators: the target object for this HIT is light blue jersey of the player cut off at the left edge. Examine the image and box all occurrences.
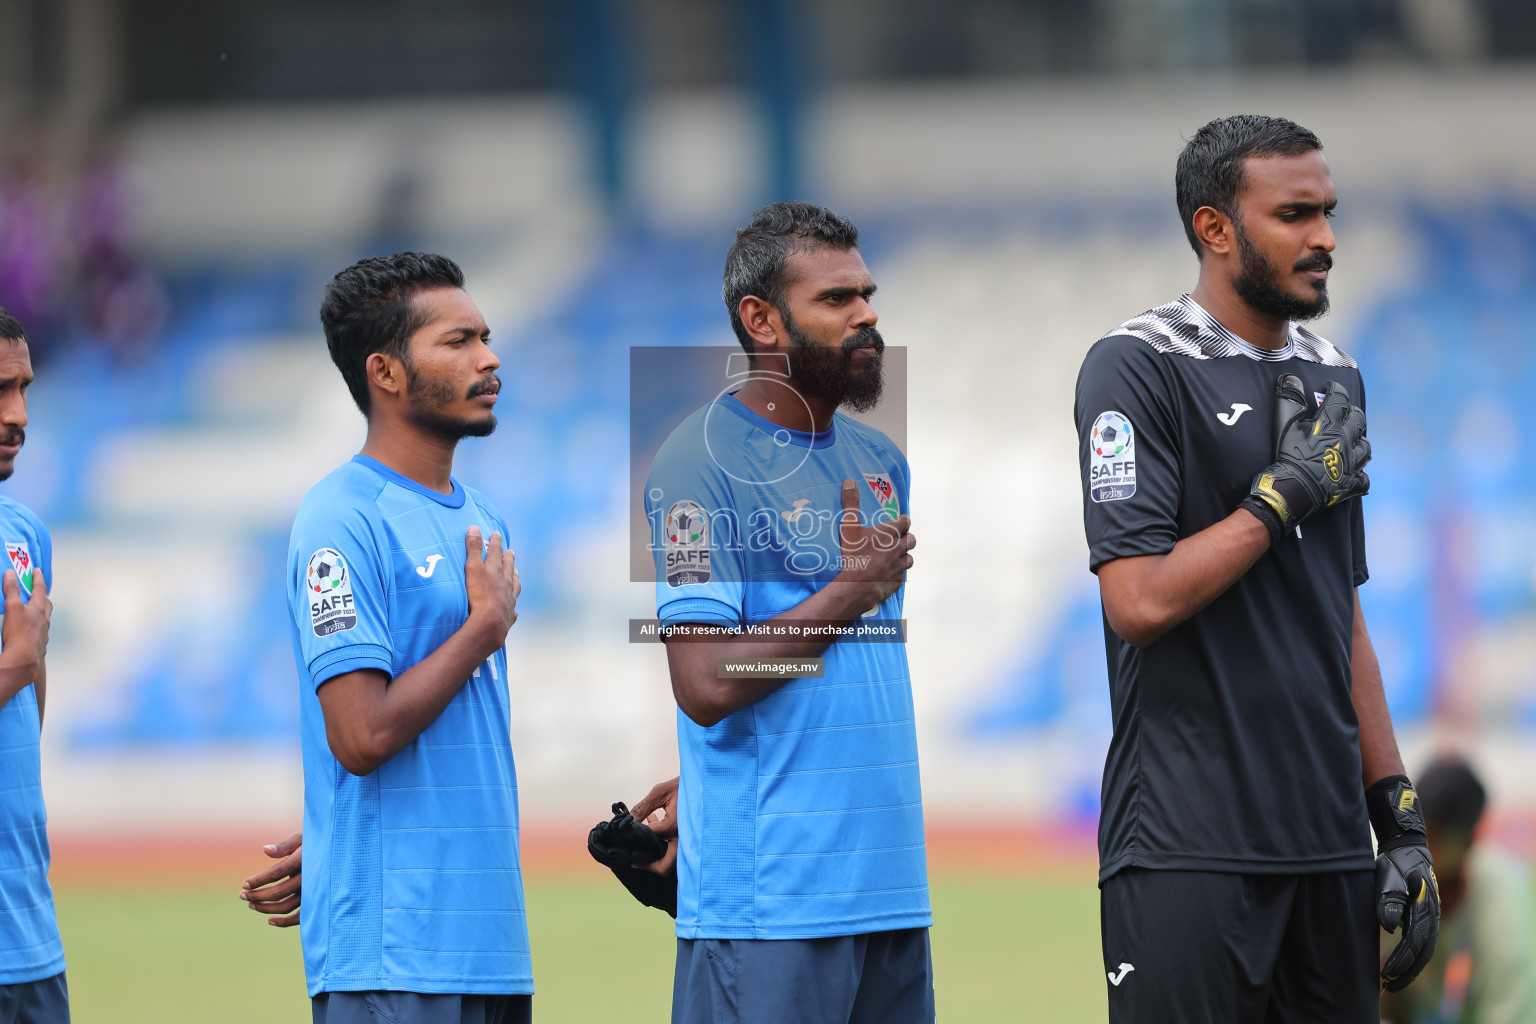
[0,496,65,986]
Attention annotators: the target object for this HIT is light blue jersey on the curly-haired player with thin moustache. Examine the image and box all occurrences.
[287,454,533,995]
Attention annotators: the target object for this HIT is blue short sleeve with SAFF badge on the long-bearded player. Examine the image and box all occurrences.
[645,419,748,626]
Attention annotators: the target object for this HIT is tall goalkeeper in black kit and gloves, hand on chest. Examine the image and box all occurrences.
[1075,117,1439,1024]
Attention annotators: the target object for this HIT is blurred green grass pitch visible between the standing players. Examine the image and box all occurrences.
[55,872,1104,1024]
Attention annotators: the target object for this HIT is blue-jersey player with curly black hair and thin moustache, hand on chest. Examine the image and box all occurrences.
[241,252,533,1024]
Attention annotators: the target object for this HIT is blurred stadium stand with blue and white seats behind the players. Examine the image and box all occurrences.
[0,0,1536,831]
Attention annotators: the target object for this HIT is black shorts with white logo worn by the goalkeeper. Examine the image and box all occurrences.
[1100,867,1381,1024]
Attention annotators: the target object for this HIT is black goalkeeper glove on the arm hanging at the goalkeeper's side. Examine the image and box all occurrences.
[1366,775,1439,992]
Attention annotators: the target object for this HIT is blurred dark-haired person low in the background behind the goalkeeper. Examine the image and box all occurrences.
[1381,757,1536,1024]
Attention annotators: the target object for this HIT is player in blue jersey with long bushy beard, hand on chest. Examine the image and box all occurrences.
[636,203,934,1024]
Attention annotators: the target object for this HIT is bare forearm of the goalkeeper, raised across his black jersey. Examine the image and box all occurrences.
[1098,508,1270,648]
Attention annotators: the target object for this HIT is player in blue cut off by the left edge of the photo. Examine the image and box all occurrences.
[0,309,69,1024]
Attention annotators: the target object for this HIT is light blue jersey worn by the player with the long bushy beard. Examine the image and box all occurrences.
[645,395,932,938]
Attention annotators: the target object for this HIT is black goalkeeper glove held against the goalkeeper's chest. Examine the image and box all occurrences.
[1238,373,1370,543]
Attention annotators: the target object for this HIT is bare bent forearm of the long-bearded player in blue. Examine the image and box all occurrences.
[667,580,879,728]
